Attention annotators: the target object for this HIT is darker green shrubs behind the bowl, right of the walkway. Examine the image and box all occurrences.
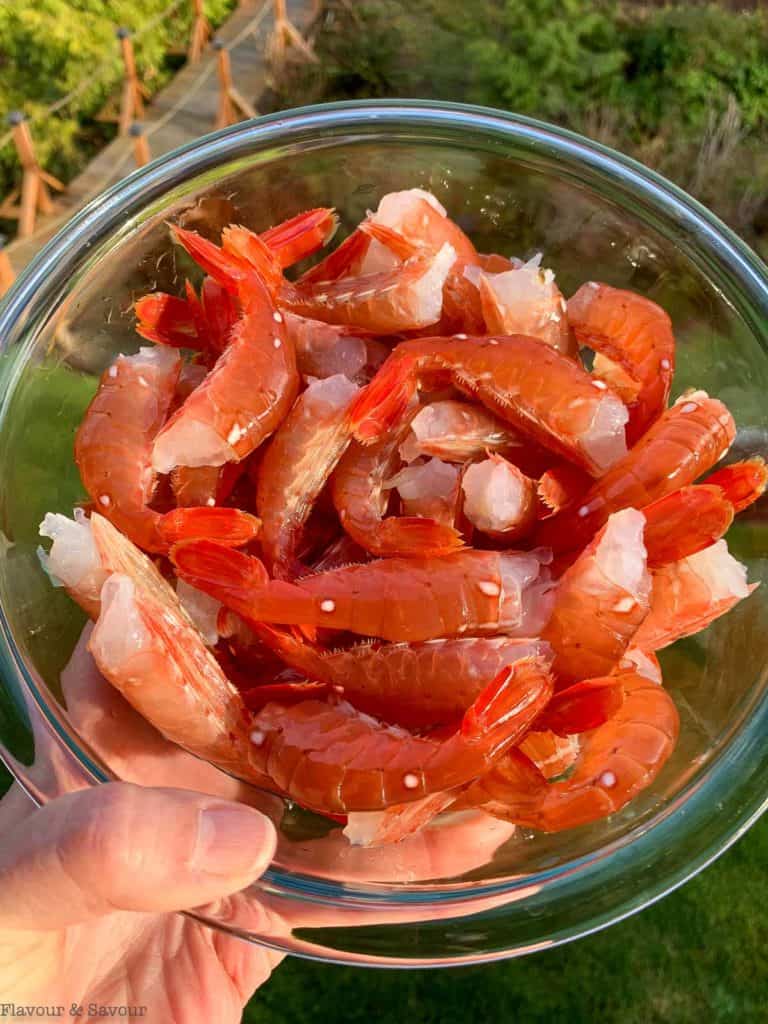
[274,0,768,251]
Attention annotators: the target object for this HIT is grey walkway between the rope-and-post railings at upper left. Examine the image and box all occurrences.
[5,0,312,273]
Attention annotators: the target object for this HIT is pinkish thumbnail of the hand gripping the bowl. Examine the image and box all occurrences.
[191,802,274,876]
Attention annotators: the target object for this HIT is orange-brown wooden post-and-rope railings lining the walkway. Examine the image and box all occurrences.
[0,0,323,256]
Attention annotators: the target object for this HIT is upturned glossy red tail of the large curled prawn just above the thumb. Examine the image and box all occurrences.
[461,656,554,756]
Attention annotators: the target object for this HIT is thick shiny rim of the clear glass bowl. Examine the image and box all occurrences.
[0,99,768,967]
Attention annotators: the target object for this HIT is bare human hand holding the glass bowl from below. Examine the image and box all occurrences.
[0,633,281,1024]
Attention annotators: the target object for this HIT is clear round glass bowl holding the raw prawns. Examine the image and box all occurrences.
[0,101,768,966]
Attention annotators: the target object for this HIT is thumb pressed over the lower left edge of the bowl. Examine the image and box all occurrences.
[0,782,275,931]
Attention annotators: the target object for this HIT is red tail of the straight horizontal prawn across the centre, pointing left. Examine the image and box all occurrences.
[171,540,269,603]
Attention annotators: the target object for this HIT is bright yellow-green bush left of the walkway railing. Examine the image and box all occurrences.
[0,0,234,235]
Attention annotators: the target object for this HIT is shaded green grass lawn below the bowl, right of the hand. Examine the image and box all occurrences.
[245,818,768,1024]
